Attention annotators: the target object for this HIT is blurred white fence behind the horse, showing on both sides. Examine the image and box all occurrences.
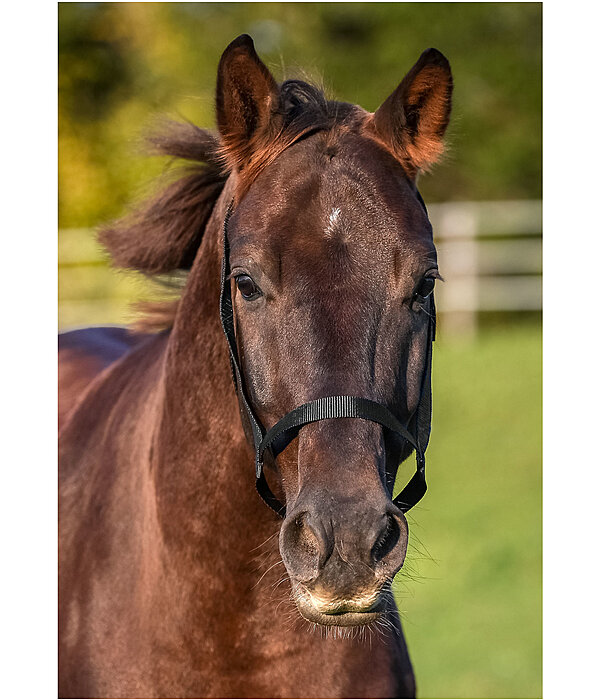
[59,200,542,332]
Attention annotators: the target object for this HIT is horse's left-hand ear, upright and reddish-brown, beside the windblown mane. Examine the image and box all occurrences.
[217,34,279,170]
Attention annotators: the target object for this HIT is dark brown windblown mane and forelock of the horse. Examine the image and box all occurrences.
[98,80,357,333]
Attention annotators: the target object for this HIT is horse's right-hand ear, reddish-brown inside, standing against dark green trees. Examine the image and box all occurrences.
[372,49,452,177]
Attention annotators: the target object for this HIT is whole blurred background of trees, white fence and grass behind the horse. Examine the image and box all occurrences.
[58,2,542,698]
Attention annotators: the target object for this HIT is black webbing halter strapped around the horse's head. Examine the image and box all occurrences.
[220,192,435,517]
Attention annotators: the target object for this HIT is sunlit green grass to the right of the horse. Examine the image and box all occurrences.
[395,326,542,698]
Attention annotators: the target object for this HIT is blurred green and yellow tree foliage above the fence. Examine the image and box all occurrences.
[59,3,541,227]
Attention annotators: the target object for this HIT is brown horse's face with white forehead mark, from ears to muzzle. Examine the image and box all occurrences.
[217,34,449,625]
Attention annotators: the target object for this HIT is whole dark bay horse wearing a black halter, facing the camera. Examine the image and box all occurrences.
[59,35,452,698]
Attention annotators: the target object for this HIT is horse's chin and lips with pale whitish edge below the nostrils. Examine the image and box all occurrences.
[292,583,385,627]
